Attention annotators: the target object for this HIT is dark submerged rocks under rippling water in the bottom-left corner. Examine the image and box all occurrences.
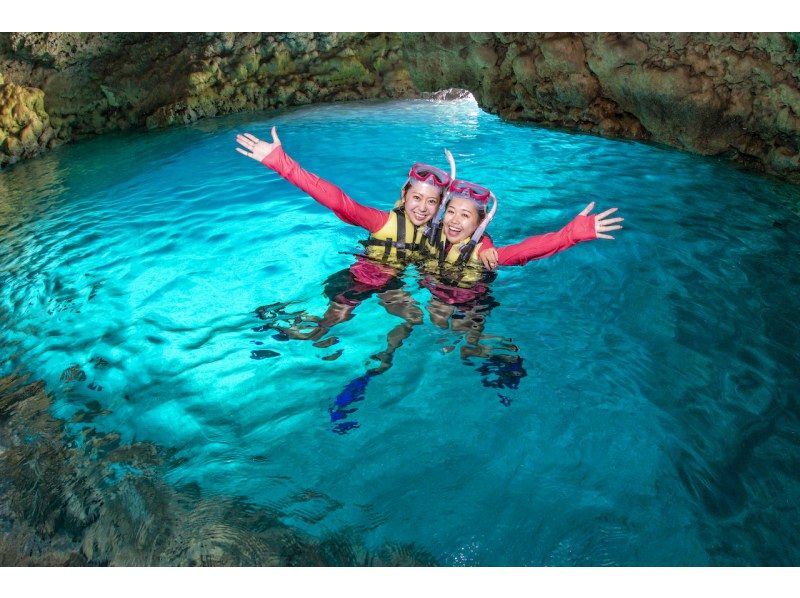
[0,376,435,566]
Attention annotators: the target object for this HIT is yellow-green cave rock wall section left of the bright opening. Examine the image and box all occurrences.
[0,33,416,166]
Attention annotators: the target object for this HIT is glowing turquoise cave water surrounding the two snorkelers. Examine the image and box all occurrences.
[0,101,800,565]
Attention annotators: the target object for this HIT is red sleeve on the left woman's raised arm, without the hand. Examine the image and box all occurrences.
[261,145,389,233]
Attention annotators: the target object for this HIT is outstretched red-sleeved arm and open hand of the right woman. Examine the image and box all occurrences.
[497,202,624,266]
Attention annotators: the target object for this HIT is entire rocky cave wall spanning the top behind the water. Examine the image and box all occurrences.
[0,33,800,182]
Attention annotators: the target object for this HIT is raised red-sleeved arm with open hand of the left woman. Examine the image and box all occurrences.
[236,127,389,233]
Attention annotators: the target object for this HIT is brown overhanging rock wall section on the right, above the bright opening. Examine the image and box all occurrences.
[403,33,800,181]
